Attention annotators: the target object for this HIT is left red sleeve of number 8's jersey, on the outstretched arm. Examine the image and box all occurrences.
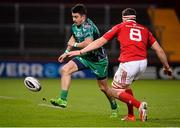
[103,25,119,40]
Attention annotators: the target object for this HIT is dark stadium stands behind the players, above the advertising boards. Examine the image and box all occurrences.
[0,0,180,79]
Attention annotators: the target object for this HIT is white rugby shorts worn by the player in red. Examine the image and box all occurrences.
[112,59,147,88]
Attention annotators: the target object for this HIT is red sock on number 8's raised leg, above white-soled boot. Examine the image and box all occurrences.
[119,92,141,108]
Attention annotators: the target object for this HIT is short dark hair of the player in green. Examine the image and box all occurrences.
[71,4,87,15]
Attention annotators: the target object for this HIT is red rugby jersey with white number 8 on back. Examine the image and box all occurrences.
[103,21,156,62]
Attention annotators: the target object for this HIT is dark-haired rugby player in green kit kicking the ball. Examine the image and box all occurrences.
[50,4,118,117]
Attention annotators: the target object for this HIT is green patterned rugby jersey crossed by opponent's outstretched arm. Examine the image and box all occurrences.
[71,18,107,62]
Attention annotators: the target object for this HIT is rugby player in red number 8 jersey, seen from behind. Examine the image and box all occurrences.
[68,8,172,122]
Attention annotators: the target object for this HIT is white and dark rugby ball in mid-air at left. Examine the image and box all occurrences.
[24,76,41,92]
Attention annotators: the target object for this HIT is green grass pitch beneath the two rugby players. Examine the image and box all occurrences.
[0,78,180,127]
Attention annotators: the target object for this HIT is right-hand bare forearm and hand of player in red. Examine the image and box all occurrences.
[152,41,172,77]
